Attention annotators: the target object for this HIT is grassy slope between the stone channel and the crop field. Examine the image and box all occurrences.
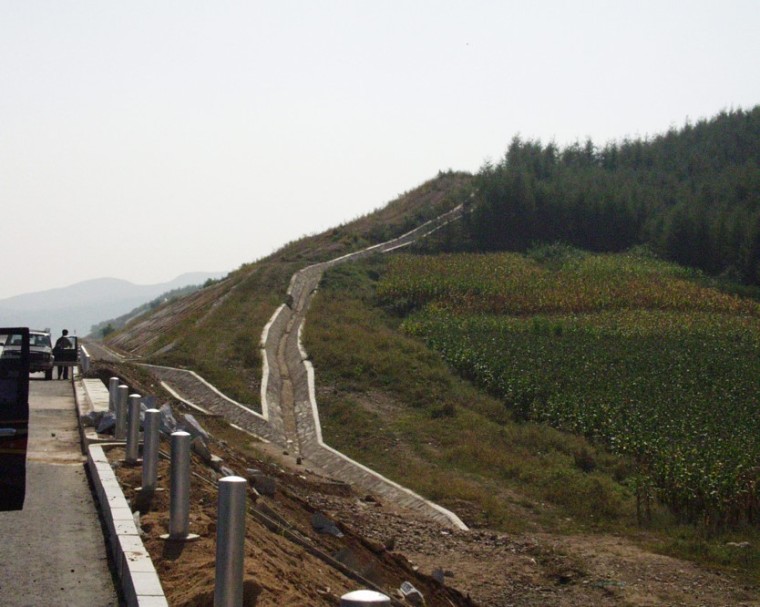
[305,258,634,531]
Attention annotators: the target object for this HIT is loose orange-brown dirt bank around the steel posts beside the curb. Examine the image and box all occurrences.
[109,436,474,607]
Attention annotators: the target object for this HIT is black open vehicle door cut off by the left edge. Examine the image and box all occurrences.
[0,328,29,510]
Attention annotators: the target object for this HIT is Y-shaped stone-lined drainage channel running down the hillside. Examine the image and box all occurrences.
[137,205,467,529]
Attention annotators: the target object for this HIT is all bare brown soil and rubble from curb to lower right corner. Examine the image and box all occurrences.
[96,370,760,607]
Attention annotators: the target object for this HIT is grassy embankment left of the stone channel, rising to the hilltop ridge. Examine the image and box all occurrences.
[105,172,472,406]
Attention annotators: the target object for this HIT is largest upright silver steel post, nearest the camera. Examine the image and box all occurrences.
[214,476,248,607]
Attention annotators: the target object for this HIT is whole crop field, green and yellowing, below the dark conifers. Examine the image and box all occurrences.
[380,255,760,526]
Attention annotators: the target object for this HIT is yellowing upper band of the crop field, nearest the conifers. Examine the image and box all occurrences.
[378,253,760,318]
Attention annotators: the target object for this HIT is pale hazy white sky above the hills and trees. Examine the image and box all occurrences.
[0,0,760,298]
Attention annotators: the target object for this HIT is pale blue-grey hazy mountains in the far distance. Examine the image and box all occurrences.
[0,272,225,337]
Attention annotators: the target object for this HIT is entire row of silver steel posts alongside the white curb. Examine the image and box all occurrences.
[108,377,391,607]
